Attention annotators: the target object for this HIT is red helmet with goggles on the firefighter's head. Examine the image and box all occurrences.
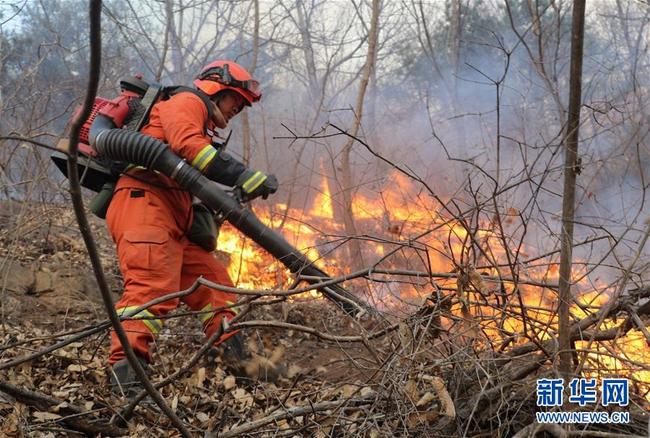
[194,59,262,106]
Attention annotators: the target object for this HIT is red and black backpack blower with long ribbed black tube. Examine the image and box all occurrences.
[52,77,369,316]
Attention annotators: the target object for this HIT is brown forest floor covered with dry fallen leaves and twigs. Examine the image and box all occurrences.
[0,202,648,437]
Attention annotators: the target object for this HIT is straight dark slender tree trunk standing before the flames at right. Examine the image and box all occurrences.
[558,0,585,379]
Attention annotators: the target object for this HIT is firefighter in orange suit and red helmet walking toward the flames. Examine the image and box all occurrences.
[106,60,278,396]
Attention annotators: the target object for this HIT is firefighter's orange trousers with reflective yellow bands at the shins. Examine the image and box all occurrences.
[106,176,236,365]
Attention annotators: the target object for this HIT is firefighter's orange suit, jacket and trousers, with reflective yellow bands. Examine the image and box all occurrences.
[106,92,236,365]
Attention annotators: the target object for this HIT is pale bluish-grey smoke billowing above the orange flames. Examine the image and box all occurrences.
[235,3,649,292]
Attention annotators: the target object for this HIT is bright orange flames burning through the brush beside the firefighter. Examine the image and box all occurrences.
[218,172,650,400]
